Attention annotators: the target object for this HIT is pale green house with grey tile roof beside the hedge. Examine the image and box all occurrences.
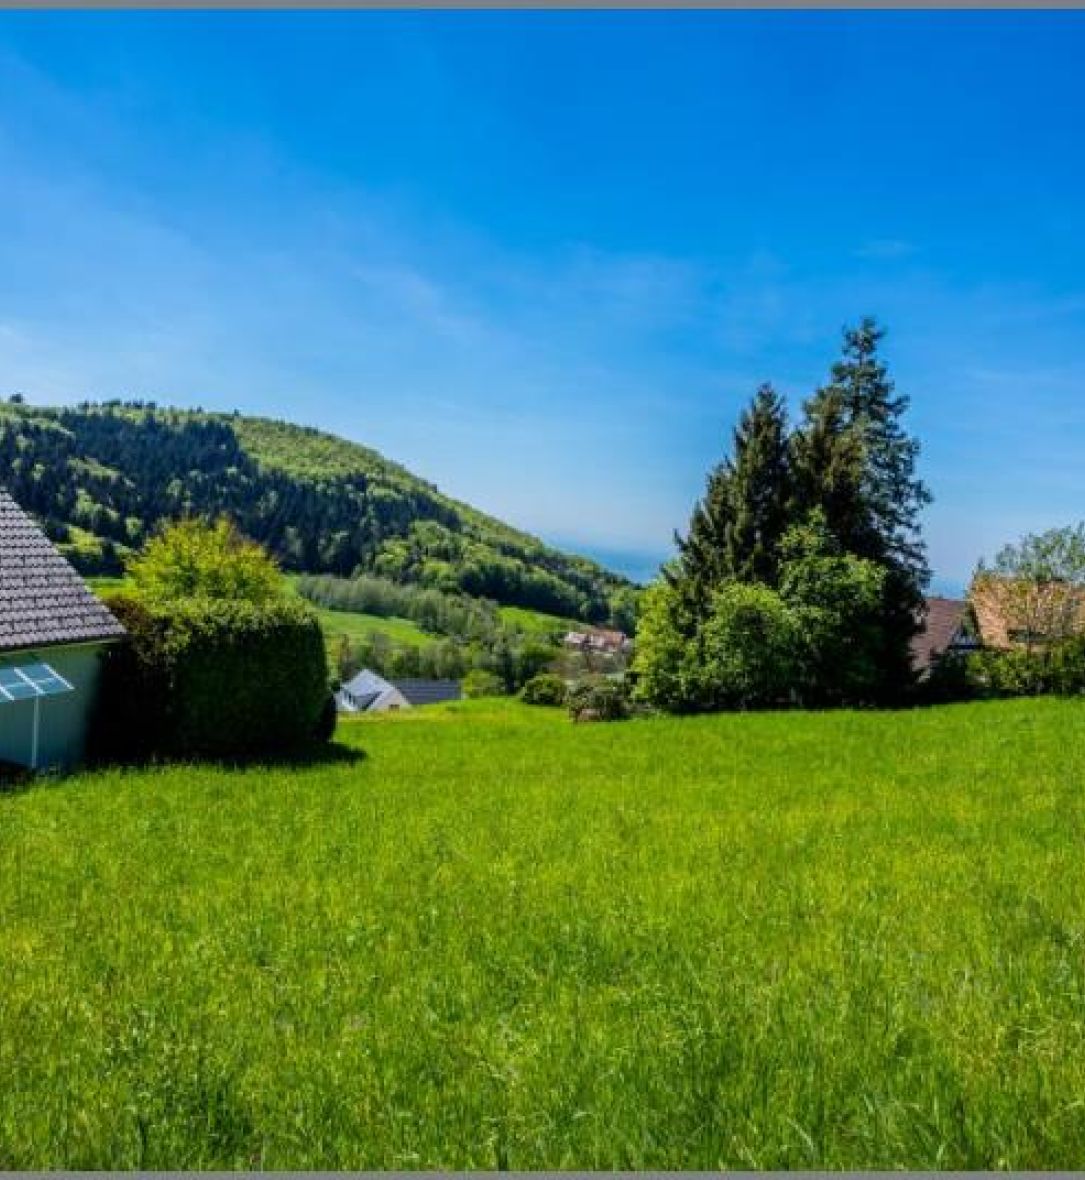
[0,491,124,769]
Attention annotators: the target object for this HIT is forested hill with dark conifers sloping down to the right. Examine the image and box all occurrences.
[0,402,635,628]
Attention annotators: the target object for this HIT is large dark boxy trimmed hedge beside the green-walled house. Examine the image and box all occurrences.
[92,595,331,760]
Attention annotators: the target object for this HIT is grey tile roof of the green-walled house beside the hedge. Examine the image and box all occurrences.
[0,490,124,651]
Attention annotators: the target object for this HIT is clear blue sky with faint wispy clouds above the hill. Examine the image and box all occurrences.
[0,12,1085,590]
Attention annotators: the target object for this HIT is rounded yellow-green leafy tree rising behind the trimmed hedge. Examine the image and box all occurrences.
[128,517,286,603]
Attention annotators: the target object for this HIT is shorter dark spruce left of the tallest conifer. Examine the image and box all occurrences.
[675,385,792,608]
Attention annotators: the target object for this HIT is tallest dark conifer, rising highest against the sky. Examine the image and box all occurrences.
[792,319,930,699]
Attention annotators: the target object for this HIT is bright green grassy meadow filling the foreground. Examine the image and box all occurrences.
[0,701,1085,1169]
